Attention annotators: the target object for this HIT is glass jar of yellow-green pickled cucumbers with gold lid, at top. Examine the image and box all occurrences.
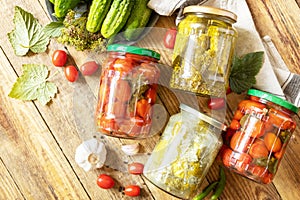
[170,6,237,96]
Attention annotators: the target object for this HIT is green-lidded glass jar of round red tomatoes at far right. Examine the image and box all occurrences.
[219,89,298,183]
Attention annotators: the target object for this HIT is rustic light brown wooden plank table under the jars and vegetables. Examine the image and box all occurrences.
[0,0,300,200]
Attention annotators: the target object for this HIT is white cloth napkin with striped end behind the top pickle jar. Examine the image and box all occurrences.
[148,0,300,107]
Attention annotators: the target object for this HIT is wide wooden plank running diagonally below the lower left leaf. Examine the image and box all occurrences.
[0,46,88,199]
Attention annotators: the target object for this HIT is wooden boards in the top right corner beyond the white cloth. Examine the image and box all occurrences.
[247,0,300,74]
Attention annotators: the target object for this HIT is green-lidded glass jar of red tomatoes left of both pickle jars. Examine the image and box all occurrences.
[96,44,160,138]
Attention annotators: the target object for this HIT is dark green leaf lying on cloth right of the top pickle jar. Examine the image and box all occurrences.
[229,51,264,94]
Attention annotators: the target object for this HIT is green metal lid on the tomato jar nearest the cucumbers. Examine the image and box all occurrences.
[107,44,160,60]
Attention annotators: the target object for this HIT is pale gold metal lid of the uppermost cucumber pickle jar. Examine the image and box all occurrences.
[183,6,237,22]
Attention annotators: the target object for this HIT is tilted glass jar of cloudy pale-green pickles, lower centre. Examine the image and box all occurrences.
[143,104,225,199]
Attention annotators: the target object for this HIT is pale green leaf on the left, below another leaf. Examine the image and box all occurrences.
[8,64,57,105]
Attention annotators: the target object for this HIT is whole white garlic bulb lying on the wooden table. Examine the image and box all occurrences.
[75,138,107,171]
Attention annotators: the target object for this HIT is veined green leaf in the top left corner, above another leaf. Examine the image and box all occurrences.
[8,6,49,56]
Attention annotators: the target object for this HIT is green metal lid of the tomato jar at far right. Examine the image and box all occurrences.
[248,89,298,113]
